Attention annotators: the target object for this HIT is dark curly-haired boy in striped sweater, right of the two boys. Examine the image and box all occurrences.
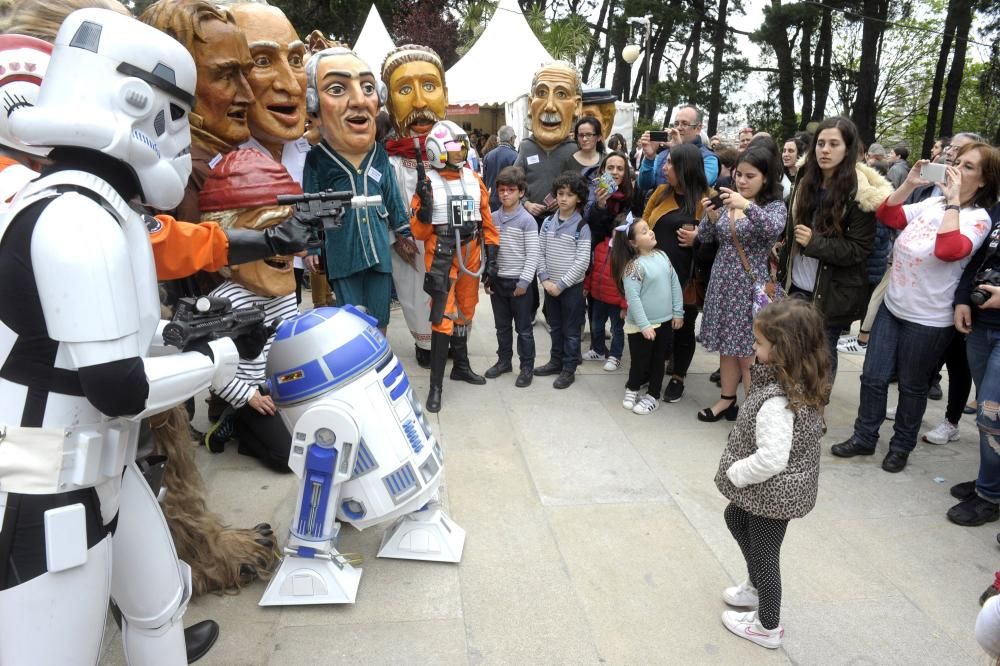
[535,171,590,389]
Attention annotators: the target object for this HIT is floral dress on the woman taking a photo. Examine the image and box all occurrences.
[698,201,786,357]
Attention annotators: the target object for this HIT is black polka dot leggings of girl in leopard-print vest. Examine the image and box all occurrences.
[723,502,788,629]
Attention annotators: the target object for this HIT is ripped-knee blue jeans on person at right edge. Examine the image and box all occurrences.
[966,324,1000,502]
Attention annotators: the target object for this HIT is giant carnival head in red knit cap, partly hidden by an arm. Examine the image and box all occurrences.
[198,150,302,298]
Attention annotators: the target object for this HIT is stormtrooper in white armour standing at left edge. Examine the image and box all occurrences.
[0,9,238,666]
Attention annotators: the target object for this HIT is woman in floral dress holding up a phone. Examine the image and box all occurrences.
[696,146,785,421]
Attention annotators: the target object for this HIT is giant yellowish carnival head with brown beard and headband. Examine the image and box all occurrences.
[382,44,448,138]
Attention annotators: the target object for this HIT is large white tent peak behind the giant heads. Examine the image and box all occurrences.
[445,0,553,105]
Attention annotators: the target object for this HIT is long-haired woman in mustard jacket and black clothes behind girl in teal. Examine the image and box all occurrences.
[642,143,709,402]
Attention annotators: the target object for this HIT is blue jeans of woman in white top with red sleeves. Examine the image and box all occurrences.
[854,303,955,453]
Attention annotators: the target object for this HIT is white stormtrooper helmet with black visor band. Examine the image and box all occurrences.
[10,9,196,210]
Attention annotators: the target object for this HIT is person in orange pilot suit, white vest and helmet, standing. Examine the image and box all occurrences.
[410,120,500,412]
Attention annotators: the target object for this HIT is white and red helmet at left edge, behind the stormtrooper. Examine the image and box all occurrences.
[0,34,52,156]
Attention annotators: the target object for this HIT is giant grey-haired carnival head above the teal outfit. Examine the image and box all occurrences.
[306,46,383,160]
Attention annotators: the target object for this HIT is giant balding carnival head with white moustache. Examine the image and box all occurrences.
[528,60,583,149]
